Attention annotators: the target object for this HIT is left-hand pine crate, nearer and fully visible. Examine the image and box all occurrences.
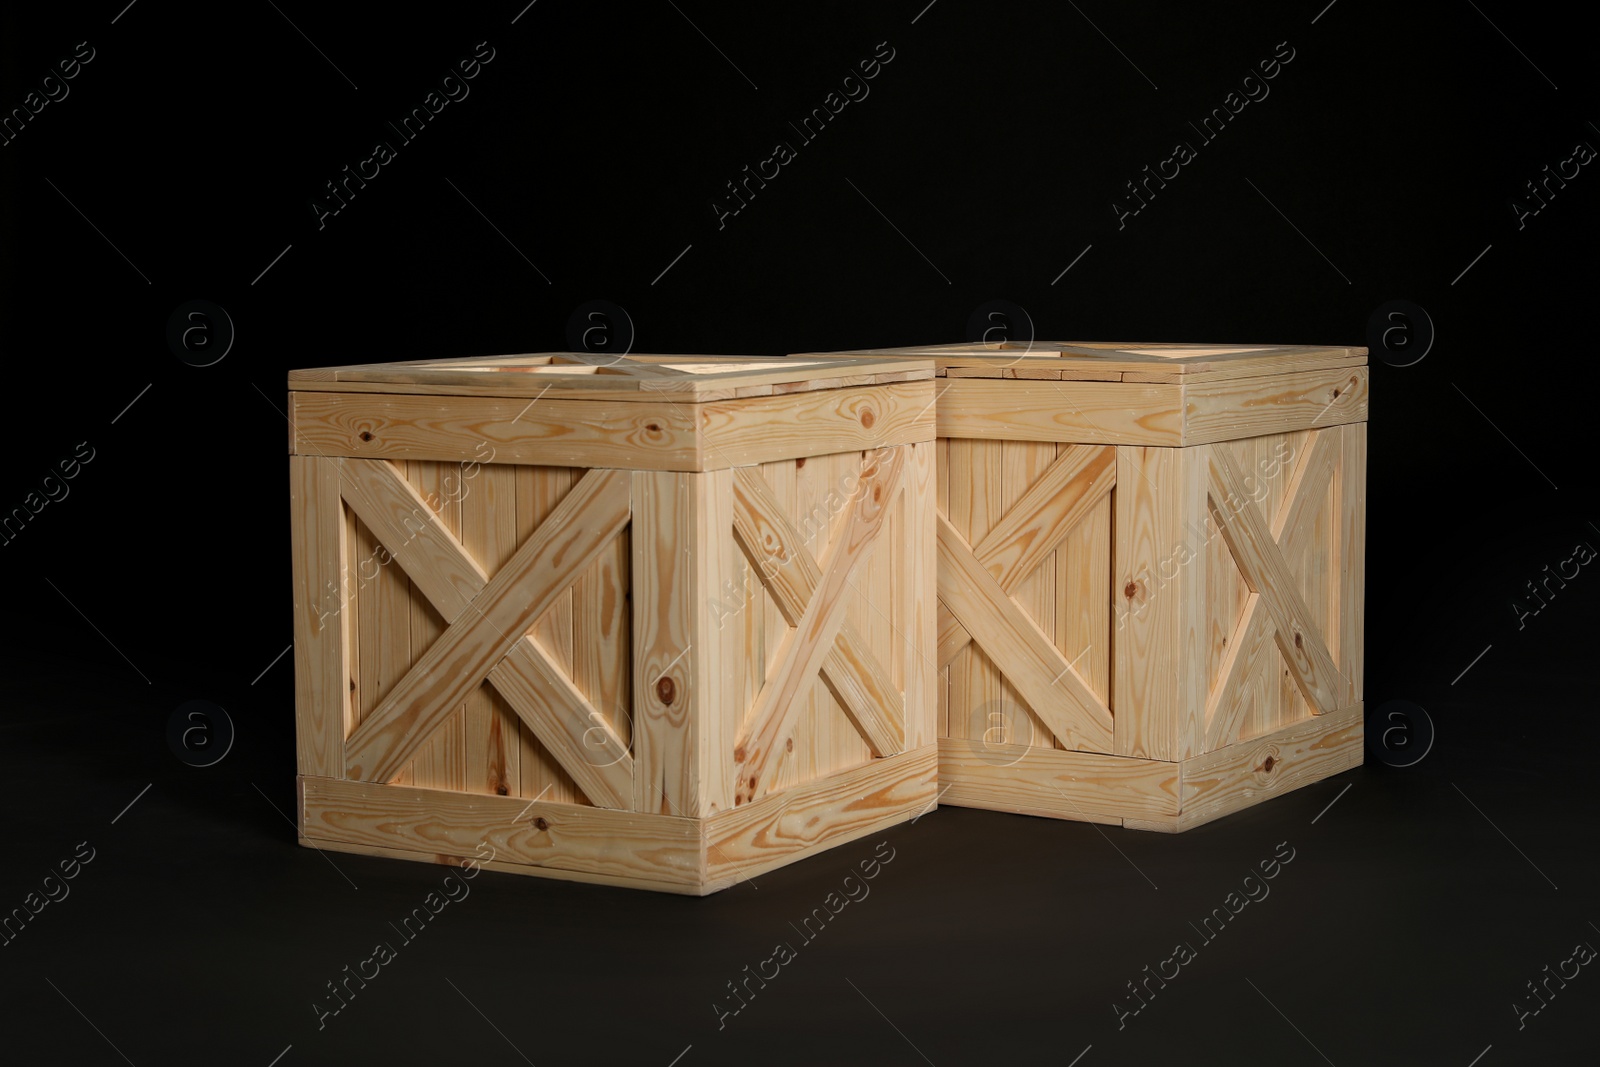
[290,354,938,894]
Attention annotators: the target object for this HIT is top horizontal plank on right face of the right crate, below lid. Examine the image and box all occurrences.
[1184,366,1368,445]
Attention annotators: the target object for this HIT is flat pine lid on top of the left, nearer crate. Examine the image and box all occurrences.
[288,352,934,403]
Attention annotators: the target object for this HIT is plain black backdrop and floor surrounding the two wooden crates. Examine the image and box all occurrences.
[0,0,1600,1067]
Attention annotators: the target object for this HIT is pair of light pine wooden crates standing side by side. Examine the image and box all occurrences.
[290,344,1368,894]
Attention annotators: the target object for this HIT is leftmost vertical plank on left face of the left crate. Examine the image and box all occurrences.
[290,456,352,777]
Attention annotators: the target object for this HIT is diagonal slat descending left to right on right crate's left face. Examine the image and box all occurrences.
[938,515,1112,752]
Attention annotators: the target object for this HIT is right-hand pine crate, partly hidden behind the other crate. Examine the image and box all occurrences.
[793,342,1368,832]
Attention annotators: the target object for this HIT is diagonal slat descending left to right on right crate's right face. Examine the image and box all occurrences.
[1208,446,1342,715]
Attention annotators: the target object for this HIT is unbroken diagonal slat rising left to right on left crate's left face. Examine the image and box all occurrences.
[346,470,629,781]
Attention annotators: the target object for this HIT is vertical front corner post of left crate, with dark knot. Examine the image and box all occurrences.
[632,472,738,817]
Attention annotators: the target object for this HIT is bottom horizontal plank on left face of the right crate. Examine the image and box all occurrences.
[939,737,1179,822]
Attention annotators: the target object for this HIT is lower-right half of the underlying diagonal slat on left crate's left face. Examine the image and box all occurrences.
[488,637,634,809]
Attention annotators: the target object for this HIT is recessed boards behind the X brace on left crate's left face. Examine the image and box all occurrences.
[328,461,632,806]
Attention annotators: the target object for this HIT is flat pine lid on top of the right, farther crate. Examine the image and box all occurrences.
[790,341,1366,384]
